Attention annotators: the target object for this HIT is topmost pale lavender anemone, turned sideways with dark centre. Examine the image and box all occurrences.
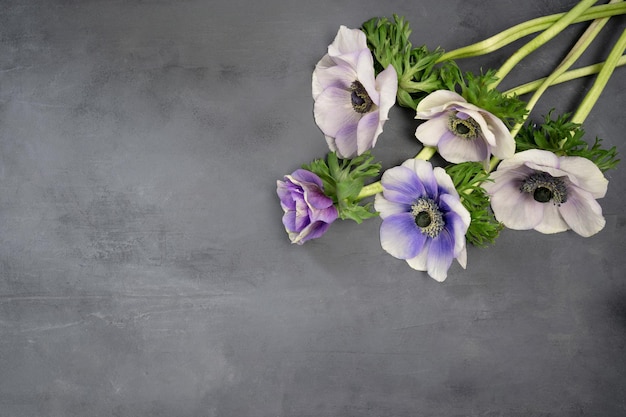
[312,26,398,158]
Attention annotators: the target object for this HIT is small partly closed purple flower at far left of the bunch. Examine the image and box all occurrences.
[276,169,338,245]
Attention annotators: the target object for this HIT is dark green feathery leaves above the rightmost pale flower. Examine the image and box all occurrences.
[515,112,620,172]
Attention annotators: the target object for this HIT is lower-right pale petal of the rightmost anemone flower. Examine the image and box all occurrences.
[559,186,606,237]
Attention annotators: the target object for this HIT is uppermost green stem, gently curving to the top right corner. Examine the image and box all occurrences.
[437,3,626,62]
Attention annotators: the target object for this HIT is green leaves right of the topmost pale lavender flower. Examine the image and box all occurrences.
[361,14,461,110]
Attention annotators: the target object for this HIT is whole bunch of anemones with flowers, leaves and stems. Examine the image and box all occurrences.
[277,0,626,281]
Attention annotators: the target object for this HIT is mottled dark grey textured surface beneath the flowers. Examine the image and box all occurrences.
[0,0,626,417]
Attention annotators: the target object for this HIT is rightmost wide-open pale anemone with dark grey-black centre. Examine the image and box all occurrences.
[483,149,608,237]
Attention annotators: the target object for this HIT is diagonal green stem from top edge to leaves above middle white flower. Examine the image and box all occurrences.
[491,0,597,88]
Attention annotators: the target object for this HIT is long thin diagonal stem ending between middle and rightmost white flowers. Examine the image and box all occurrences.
[511,0,608,137]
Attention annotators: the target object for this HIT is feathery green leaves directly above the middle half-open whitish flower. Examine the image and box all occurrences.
[459,69,528,129]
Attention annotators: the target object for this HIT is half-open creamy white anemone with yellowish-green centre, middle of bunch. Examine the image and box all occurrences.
[415,90,515,168]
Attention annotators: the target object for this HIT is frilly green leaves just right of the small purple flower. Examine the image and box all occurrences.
[302,151,381,223]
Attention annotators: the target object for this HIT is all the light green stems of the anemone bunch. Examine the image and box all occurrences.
[357,0,626,199]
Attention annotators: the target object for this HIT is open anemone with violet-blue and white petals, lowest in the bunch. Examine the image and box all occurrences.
[374,159,470,282]
